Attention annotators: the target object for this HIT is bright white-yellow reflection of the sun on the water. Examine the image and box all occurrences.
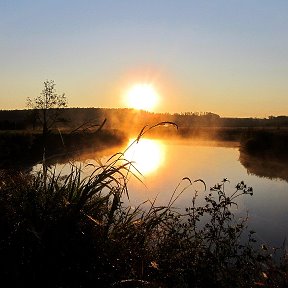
[124,138,165,176]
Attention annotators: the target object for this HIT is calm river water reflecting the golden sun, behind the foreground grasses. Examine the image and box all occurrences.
[32,138,288,247]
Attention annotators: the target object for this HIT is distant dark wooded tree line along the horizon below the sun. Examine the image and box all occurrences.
[0,108,288,130]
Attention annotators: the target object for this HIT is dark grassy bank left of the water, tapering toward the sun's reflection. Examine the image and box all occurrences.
[0,129,127,169]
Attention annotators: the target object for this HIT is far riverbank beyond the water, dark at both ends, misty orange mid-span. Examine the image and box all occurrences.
[0,126,288,169]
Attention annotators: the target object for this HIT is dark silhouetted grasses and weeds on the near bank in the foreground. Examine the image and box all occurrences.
[0,139,288,288]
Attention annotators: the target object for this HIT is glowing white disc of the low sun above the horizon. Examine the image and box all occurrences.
[126,84,159,111]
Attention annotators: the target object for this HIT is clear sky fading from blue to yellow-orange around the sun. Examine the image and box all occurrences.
[0,0,288,118]
